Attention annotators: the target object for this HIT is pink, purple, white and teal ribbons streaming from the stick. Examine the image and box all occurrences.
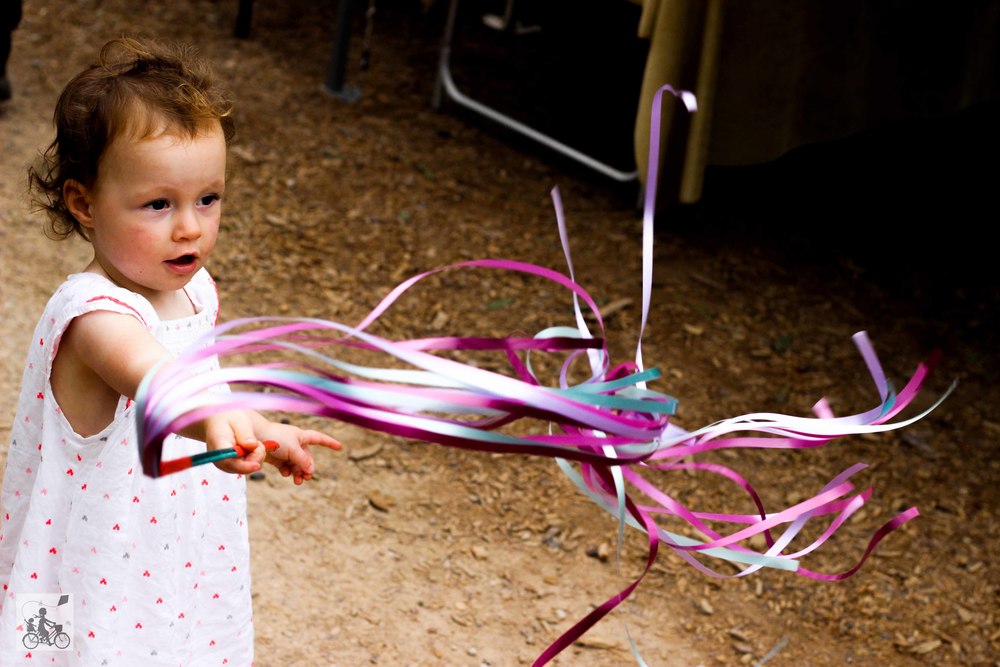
[136,86,954,665]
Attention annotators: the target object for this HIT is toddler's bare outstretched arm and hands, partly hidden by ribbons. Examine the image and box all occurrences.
[52,311,340,484]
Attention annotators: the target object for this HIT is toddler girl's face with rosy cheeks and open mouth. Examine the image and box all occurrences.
[81,127,226,305]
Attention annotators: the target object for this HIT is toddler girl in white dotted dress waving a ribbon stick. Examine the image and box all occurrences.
[0,38,340,667]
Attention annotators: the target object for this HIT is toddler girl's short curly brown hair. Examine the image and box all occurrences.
[28,37,235,240]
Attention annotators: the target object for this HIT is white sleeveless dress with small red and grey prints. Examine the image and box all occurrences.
[0,269,253,667]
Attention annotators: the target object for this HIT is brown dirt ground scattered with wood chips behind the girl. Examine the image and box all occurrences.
[0,0,1000,667]
